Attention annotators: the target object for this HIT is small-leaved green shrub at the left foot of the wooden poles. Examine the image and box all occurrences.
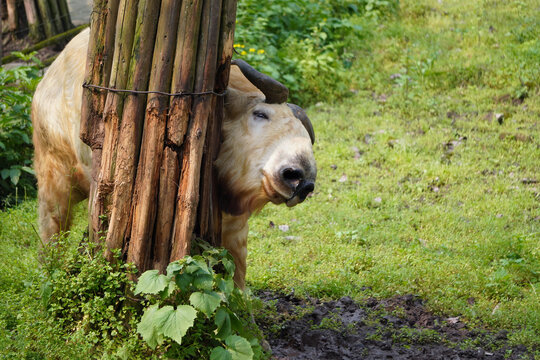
[41,234,150,359]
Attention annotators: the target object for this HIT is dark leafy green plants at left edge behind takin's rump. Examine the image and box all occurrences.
[0,53,41,206]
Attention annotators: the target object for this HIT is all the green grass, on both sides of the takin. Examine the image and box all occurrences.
[0,0,540,358]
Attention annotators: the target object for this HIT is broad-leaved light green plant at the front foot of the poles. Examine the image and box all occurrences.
[135,249,263,360]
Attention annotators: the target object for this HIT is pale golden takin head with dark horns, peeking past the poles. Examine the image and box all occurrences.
[216,60,317,215]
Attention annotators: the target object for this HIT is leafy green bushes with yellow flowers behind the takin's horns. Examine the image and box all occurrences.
[235,0,398,104]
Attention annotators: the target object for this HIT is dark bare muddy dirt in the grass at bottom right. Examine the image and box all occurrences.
[257,291,532,360]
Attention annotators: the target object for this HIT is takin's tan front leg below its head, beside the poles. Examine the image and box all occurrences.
[221,213,249,290]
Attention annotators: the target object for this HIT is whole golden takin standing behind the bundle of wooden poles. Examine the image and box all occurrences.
[32,30,317,288]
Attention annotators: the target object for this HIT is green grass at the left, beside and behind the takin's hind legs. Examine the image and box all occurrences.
[0,200,89,360]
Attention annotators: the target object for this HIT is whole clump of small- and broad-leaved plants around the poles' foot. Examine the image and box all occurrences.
[41,235,263,360]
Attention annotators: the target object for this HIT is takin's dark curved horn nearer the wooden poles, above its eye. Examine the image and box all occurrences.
[231,59,289,104]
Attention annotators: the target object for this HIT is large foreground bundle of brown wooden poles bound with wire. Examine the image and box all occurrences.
[81,0,236,272]
